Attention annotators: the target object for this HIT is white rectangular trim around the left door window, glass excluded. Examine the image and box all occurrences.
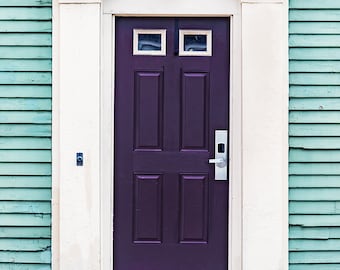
[133,29,166,56]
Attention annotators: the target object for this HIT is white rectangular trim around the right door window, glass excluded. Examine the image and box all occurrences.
[178,29,212,56]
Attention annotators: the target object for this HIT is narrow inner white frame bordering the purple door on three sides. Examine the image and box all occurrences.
[101,5,242,270]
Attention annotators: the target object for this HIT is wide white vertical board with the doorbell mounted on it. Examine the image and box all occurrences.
[54,1,100,270]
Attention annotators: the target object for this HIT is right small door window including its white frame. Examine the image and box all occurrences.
[179,30,212,56]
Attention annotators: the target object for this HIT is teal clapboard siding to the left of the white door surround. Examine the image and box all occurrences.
[0,0,52,270]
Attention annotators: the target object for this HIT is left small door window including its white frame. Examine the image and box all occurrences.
[133,29,166,55]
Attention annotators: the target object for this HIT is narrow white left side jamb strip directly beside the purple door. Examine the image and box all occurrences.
[100,14,115,270]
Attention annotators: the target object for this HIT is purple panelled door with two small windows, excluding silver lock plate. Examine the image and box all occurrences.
[114,18,229,270]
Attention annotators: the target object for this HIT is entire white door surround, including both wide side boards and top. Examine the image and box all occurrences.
[52,0,288,270]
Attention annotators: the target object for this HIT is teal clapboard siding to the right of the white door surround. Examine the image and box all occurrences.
[289,0,340,270]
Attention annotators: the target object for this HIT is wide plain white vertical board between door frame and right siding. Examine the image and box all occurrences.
[242,0,288,270]
